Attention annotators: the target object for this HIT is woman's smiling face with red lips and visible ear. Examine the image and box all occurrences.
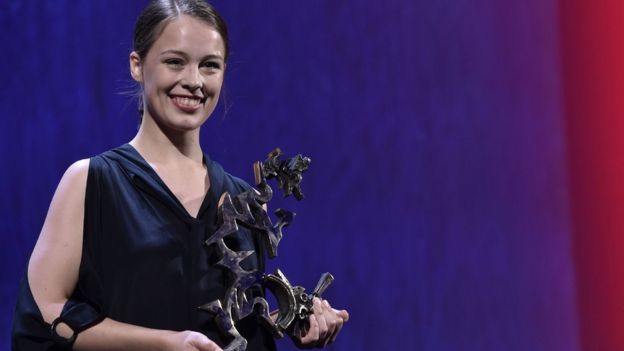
[130,16,225,131]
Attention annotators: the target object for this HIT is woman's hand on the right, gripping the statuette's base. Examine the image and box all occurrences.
[293,297,349,349]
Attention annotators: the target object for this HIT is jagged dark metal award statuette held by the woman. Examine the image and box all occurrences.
[199,149,334,351]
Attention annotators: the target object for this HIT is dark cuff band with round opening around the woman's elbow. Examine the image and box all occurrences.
[51,300,104,349]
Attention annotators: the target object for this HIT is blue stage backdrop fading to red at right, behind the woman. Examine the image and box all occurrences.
[0,0,624,351]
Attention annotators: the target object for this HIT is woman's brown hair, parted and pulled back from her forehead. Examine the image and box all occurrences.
[133,0,229,60]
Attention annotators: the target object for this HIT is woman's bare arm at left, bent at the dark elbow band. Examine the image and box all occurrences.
[28,160,221,351]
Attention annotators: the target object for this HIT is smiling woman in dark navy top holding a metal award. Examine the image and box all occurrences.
[13,0,348,350]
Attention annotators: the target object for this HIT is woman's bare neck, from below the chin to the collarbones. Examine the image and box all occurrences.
[130,117,203,164]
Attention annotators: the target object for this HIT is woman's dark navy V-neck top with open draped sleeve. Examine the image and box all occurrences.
[13,144,275,351]
